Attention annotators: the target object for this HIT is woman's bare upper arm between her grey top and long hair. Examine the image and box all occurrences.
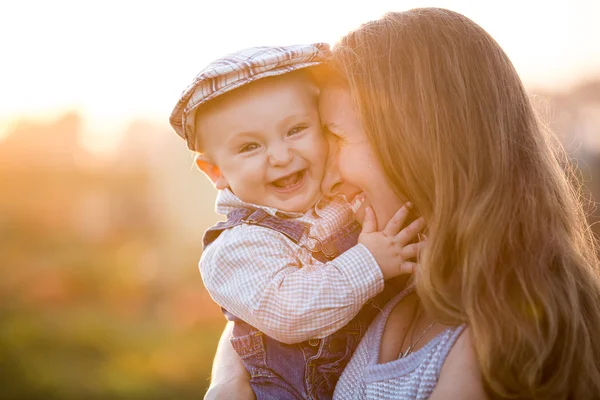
[429,328,488,400]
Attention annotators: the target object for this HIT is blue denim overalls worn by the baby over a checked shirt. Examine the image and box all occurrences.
[203,208,398,400]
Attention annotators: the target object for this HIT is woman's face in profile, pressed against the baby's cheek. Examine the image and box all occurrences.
[319,86,402,229]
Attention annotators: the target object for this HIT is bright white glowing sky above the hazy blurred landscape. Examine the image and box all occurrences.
[0,0,600,154]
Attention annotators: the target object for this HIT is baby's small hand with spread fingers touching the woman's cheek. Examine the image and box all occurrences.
[358,203,425,279]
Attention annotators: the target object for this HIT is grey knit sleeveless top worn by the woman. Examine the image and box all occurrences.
[333,289,465,400]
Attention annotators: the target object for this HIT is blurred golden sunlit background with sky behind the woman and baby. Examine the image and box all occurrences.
[0,0,600,399]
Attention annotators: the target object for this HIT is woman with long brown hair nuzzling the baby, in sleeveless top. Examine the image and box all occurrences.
[209,9,600,399]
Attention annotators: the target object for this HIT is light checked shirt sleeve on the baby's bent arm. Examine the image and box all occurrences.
[200,225,383,344]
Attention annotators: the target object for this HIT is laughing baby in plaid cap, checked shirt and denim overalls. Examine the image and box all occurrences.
[171,43,423,399]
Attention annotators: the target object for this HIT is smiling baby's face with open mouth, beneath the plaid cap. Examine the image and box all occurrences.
[196,75,328,212]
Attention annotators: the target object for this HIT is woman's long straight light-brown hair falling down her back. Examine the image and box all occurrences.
[332,9,600,399]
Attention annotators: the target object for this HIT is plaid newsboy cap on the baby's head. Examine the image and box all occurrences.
[169,43,331,150]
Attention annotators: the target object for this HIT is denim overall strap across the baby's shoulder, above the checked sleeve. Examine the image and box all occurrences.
[202,208,309,248]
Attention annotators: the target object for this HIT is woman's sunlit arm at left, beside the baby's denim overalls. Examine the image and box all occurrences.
[204,322,254,400]
